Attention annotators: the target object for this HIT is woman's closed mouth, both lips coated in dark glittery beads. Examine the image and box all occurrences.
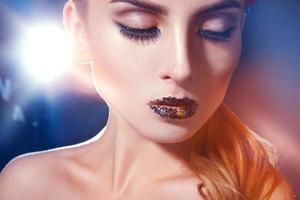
[148,97,198,120]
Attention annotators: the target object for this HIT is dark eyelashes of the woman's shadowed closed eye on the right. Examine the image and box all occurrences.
[197,27,236,42]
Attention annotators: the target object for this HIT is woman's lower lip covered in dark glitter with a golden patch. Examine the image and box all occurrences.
[150,105,197,120]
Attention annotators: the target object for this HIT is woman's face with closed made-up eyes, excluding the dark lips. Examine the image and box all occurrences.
[71,0,244,143]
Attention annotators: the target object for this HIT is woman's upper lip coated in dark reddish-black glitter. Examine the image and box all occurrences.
[148,96,196,106]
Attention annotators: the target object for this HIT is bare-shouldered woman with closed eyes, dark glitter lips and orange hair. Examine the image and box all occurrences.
[0,0,293,200]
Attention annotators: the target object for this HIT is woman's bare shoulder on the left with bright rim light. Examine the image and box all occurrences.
[0,143,95,200]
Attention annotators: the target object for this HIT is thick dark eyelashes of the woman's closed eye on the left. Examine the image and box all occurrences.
[117,23,160,42]
